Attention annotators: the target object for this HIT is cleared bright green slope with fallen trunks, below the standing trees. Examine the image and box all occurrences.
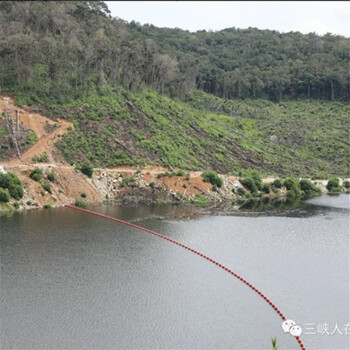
[13,89,350,176]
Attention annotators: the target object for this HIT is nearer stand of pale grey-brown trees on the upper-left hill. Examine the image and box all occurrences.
[0,1,177,101]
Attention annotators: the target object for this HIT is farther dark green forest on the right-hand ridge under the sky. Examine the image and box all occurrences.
[129,22,349,100]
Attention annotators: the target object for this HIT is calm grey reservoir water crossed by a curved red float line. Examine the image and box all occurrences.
[0,195,350,349]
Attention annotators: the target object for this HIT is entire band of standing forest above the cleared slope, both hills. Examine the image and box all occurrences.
[0,1,349,101]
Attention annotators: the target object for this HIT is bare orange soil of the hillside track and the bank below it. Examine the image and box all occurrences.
[0,95,284,213]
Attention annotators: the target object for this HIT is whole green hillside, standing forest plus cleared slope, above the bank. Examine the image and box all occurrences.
[0,1,350,176]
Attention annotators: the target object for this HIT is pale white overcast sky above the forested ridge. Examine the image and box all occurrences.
[106,1,350,37]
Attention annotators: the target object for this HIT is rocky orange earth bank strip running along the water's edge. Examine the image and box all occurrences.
[0,161,348,215]
